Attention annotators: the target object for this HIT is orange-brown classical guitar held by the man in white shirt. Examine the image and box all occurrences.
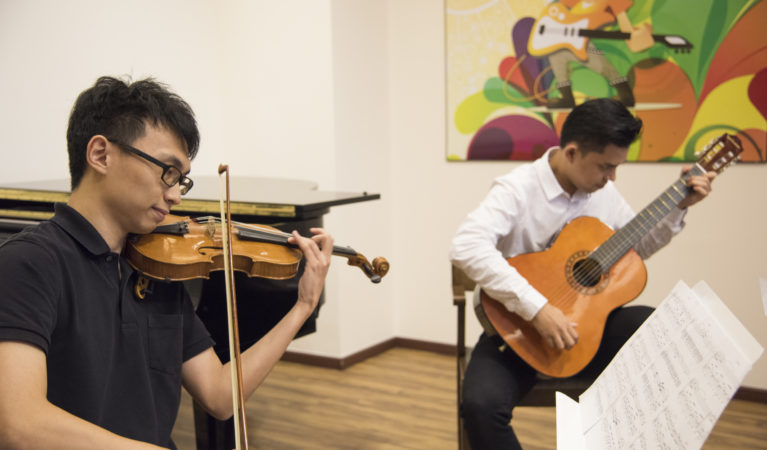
[475,134,743,377]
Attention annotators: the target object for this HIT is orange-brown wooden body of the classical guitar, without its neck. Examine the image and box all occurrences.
[477,217,647,377]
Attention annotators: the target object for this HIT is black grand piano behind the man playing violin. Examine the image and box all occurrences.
[0,177,380,450]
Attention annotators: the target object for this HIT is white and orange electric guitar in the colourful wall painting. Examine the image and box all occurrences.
[527,3,692,60]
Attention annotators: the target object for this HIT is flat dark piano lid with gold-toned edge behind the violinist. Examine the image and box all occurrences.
[0,176,381,220]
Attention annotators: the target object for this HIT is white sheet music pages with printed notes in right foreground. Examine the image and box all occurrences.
[558,282,763,449]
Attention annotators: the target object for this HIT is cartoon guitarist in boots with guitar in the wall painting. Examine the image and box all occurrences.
[527,0,692,109]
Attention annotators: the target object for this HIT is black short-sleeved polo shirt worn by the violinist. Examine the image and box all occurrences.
[0,204,212,447]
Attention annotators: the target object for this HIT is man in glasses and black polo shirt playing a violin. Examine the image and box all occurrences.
[0,77,333,449]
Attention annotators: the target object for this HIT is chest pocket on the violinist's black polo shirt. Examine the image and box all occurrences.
[148,314,183,375]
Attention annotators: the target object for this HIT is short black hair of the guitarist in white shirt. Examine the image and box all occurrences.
[560,98,642,154]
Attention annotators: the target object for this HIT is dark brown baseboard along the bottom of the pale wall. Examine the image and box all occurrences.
[282,337,767,403]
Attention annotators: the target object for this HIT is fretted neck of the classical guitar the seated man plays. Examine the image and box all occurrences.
[591,164,705,272]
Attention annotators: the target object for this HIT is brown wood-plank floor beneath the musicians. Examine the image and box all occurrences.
[173,348,767,450]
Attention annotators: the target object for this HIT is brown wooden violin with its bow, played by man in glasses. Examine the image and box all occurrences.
[125,165,389,450]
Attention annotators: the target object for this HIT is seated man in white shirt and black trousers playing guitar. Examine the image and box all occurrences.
[450,99,716,450]
